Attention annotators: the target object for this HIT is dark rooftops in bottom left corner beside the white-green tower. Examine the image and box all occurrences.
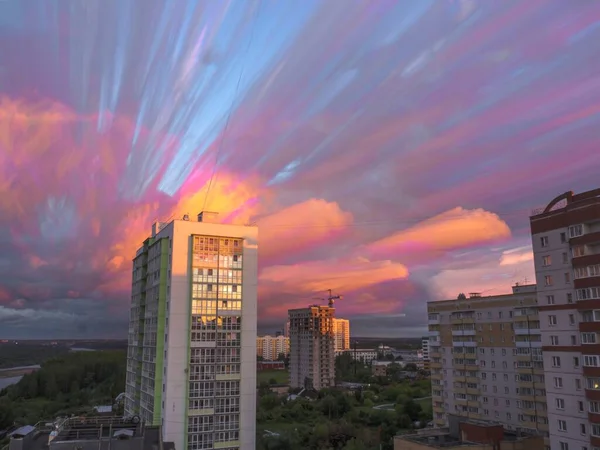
[8,417,175,450]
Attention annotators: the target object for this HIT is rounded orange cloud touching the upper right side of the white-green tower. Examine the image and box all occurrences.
[258,199,353,258]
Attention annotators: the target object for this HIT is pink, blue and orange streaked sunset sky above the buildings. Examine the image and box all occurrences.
[0,0,600,339]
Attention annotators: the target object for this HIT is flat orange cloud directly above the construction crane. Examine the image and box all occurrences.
[259,258,408,294]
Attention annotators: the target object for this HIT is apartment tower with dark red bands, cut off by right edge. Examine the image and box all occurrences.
[530,189,600,450]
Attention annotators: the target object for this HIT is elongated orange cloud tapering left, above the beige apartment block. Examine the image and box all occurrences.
[368,207,511,256]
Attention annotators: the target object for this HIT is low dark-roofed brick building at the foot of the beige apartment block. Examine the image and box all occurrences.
[394,416,544,450]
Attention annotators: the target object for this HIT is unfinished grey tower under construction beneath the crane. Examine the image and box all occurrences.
[288,305,335,390]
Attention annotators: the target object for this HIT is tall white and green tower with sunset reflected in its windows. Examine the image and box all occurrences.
[125,212,258,450]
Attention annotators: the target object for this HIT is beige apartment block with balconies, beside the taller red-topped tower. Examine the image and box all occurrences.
[427,285,548,442]
